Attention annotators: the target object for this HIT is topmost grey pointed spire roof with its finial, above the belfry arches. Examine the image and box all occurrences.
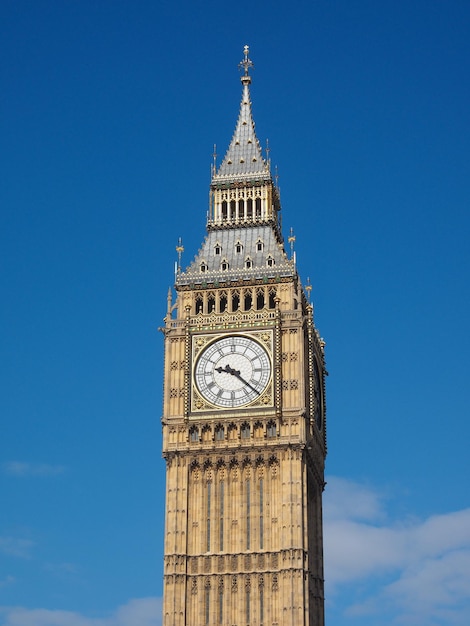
[212,46,271,183]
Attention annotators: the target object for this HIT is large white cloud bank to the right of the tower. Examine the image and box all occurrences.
[325,477,470,626]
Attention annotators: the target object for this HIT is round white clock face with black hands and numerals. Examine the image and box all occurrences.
[194,335,271,409]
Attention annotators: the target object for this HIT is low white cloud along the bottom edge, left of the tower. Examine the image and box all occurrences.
[0,598,162,626]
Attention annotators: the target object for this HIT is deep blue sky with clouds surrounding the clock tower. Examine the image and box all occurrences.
[0,0,470,626]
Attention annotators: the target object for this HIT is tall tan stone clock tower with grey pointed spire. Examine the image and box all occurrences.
[162,46,326,626]
